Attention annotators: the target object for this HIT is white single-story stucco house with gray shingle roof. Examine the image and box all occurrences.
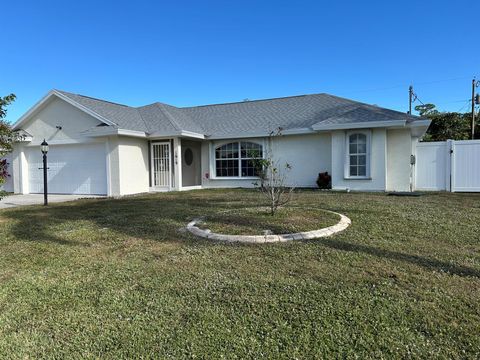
[2,90,430,196]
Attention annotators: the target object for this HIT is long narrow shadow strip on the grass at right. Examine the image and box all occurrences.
[315,238,480,278]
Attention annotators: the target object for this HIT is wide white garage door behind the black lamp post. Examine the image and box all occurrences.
[26,144,107,195]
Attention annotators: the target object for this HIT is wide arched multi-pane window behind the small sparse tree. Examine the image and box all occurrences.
[215,141,263,177]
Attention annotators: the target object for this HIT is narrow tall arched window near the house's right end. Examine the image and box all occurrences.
[346,132,370,178]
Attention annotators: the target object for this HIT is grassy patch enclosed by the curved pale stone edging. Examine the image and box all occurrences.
[198,207,340,235]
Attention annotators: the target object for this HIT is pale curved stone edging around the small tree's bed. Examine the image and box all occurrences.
[187,210,352,244]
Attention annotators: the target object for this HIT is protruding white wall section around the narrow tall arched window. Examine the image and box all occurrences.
[331,128,387,191]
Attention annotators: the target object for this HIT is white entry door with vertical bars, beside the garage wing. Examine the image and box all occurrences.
[151,142,172,189]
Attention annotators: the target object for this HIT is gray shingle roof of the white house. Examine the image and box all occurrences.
[55,91,422,136]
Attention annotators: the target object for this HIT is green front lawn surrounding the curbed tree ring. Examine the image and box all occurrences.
[0,190,480,359]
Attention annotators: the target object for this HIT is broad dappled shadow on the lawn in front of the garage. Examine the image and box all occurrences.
[1,195,255,246]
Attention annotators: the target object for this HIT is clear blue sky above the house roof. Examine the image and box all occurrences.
[0,0,480,121]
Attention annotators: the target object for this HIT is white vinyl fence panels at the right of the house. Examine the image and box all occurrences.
[415,140,480,192]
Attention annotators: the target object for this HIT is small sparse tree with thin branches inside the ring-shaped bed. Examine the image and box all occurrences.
[250,129,295,216]
